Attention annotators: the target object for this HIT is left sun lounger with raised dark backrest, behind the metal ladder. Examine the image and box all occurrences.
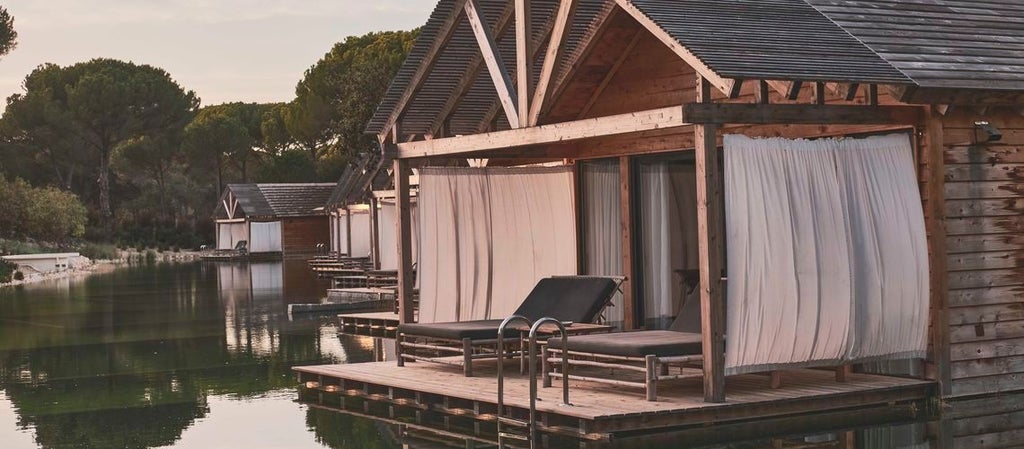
[395,276,622,377]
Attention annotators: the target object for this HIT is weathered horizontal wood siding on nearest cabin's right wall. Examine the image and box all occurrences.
[943,110,1024,397]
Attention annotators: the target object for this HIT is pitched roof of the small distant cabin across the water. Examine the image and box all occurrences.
[227,182,335,218]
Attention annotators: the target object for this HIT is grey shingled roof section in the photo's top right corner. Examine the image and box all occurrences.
[805,0,1024,90]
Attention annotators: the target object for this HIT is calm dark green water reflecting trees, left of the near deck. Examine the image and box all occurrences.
[0,261,393,449]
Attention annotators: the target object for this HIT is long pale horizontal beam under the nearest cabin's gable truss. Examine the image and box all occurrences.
[386,106,688,159]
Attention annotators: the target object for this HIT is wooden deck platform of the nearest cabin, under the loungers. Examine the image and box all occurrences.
[295,361,934,441]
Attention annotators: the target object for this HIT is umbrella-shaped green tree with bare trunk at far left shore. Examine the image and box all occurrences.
[4,59,199,238]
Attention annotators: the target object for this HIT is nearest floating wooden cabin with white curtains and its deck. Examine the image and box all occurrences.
[297,0,1024,447]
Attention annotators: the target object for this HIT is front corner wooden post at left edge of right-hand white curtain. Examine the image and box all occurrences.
[693,76,725,402]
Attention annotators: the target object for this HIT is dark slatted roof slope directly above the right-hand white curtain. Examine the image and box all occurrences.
[627,0,910,84]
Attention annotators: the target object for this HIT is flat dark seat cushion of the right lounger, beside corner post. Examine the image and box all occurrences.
[548,330,701,357]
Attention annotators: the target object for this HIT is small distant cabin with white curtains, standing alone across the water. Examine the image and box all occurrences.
[213,183,335,254]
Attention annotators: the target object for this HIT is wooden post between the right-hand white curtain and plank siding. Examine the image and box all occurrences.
[921,108,952,397]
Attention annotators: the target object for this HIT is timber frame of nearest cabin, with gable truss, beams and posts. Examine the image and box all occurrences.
[360,0,1020,402]
